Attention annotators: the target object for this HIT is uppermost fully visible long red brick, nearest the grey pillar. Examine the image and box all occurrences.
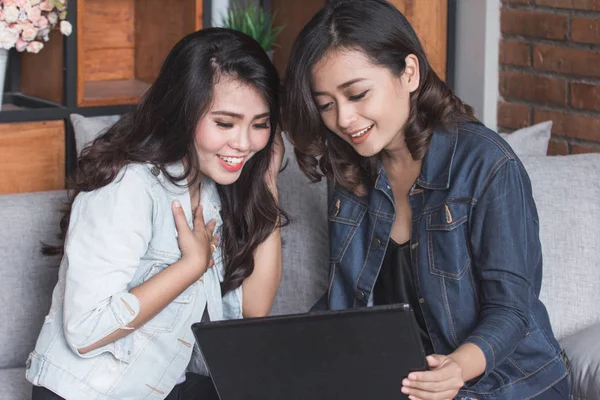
[500,8,567,40]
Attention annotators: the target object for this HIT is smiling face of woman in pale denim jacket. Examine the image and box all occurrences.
[195,77,271,185]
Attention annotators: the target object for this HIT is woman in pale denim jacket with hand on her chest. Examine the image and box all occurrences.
[27,29,285,400]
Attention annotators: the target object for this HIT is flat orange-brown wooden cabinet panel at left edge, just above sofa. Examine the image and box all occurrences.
[0,121,65,194]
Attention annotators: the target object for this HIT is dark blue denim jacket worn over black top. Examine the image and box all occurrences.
[327,124,568,399]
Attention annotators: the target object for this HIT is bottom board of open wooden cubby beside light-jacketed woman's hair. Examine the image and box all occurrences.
[81,79,150,107]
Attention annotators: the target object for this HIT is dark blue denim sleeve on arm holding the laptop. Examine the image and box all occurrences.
[465,159,541,376]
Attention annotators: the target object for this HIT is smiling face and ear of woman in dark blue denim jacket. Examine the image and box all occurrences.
[311,49,419,157]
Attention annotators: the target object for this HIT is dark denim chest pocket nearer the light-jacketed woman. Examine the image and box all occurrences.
[328,194,367,262]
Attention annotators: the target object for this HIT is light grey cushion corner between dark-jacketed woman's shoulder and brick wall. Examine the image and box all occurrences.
[500,121,552,157]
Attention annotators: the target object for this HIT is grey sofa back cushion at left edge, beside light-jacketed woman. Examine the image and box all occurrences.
[0,191,66,368]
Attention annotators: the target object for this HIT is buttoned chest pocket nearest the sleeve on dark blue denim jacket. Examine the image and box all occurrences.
[426,203,470,280]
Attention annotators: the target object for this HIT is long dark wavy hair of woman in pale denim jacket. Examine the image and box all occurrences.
[49,28,287,294]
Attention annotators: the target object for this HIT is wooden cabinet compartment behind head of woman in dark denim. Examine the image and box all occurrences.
[271,0,448,79]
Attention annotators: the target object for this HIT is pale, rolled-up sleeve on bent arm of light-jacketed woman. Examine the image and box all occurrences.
[64,167,153,359]
